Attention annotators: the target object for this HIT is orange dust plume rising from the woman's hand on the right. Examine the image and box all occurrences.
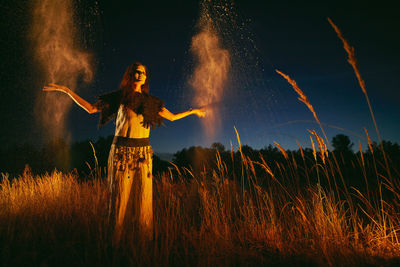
[189,16,230,139]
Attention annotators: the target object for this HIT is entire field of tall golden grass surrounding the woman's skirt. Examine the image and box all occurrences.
[0,141,400,266]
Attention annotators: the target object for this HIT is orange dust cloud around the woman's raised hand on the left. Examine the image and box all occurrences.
[31,0,93,141]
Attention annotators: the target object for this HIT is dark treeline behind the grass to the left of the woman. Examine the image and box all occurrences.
[0,135,170,179]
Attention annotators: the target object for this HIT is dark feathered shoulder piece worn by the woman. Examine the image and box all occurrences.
[95,90,164,128]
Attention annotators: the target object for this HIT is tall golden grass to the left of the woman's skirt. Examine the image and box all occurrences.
[0,171,107,266]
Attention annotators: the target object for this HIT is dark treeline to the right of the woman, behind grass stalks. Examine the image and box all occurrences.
[174,134,400,183]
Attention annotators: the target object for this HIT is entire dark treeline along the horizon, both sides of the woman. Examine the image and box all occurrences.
[0,134,400,193]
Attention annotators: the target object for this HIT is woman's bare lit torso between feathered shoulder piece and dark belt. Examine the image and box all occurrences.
[115,105,150,138]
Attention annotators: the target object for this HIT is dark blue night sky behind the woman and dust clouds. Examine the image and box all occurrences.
[0,0,400,155]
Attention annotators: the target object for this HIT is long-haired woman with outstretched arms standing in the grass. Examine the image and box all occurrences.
[43,63,205,245]
